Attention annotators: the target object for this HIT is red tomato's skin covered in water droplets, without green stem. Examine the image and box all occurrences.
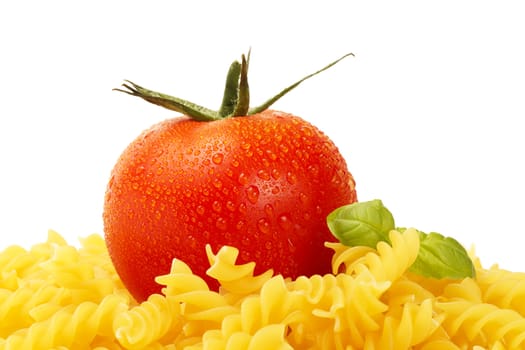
[103,110,357,301]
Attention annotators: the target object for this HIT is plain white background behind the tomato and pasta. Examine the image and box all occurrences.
[0,0,525,271]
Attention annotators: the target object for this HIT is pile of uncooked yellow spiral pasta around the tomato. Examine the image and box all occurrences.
[0,229,525,350]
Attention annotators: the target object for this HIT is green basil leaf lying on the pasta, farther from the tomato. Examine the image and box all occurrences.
[409,231,476,279]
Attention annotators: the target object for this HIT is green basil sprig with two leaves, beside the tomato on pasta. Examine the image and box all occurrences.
[327,199,475,279]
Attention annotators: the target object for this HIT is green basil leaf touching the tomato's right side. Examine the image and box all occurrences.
[326,199,395,248]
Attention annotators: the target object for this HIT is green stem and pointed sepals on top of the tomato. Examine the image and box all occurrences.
[113,52,354,121]
